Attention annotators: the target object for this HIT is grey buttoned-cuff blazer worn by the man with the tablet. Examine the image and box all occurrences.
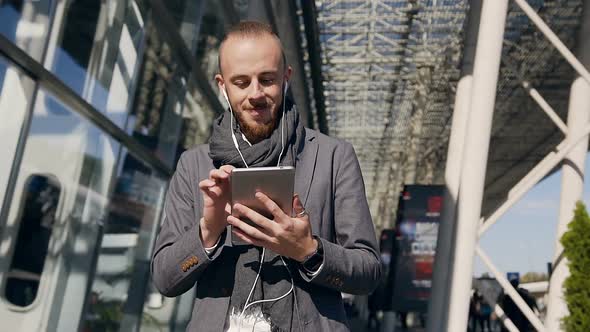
[151,129,381,332]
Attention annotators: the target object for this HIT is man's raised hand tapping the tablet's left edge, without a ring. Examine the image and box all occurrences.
[199,165,234,248]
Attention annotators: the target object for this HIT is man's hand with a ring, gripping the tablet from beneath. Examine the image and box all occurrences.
[227,192,318,262]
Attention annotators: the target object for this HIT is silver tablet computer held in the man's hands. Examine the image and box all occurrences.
[231,166,295,244]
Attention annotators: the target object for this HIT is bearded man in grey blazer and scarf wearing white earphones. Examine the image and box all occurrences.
[152,22,381,331]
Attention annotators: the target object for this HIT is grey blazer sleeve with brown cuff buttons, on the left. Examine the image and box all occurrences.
[151,152,227,296]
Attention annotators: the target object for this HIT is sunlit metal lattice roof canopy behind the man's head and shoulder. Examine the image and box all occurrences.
[314,0,469,230]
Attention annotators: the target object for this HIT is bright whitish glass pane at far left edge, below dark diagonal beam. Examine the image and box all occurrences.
[0,56,34,217]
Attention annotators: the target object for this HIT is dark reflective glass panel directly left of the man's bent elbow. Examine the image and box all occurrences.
[84,155,167,331]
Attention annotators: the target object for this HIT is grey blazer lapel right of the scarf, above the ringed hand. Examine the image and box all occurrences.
[295,128,318,206]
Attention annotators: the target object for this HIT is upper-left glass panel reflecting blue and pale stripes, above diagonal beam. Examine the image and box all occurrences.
[48,0,145,127]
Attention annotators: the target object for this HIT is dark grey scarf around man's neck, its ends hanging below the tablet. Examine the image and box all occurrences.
[209,99,305,331]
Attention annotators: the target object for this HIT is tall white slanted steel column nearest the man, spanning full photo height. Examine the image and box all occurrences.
[443,0,508,331]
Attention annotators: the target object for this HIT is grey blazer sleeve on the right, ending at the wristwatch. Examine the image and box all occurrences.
[310,143,381,295]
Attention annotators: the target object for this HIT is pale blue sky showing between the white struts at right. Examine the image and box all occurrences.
[473,154,590,277]
